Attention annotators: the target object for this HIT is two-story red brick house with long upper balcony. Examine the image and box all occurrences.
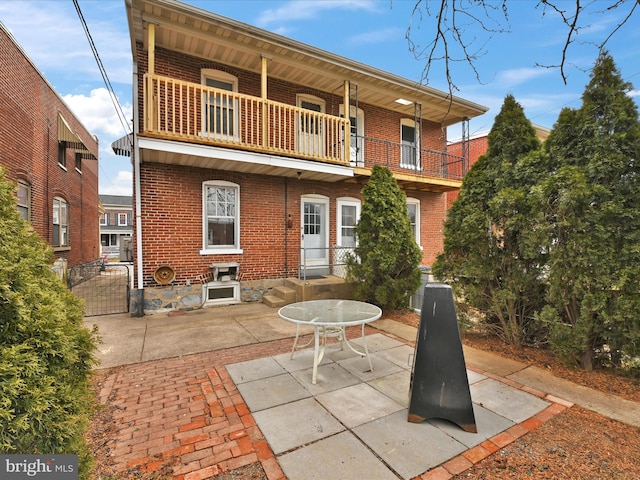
[120,0,486,313]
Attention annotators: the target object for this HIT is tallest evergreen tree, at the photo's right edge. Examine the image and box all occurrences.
[538,52,640,370]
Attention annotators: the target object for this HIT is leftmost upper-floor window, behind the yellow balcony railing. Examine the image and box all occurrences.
[201,69,239,141]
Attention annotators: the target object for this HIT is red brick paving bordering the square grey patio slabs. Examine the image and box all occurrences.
[99,327,572,480]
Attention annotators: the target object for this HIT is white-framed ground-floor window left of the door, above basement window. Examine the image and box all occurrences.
[202,181,242,253]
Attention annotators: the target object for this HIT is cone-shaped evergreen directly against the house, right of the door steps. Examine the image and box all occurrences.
[347,165,422,309]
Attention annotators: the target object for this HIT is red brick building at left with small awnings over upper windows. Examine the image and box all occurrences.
[0,23,100,267]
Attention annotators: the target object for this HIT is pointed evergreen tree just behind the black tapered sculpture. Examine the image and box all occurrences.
[433,95,544,344]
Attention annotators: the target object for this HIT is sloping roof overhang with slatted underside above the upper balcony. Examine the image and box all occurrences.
[126,0,488,127]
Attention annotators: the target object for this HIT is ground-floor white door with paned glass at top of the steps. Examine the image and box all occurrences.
[301,197,329,278]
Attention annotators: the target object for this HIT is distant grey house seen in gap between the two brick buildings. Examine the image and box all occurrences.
[100,195,133,262]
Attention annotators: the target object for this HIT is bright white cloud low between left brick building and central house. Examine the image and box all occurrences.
[62,88,133,139]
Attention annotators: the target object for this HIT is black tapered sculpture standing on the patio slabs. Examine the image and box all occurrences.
[407,283,478,433]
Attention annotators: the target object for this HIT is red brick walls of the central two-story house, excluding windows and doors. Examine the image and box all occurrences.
[134,46,446,286]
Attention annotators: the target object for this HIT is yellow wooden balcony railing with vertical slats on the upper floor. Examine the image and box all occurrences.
[144,74,349,164]
